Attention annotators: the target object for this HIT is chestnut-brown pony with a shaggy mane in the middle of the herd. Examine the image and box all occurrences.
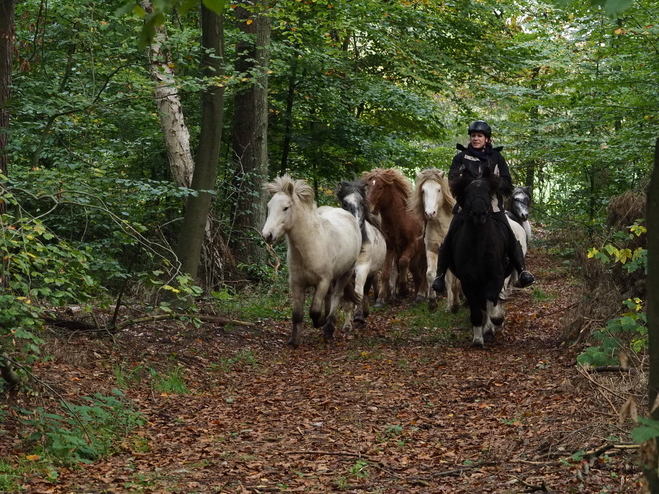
[363,168,427,307]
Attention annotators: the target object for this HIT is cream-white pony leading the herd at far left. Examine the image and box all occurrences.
[261,175,362,348]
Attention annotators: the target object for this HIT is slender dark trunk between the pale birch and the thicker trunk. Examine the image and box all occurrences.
[176,5,229,278]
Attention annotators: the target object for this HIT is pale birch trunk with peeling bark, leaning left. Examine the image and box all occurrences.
[140,0,194,187]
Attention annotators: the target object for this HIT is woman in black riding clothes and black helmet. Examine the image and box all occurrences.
[432,120,535,292]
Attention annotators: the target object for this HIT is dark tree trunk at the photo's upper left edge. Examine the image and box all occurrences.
[0,0,16,176]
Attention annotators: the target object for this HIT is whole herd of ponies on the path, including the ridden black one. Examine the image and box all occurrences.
[261,168,531,347]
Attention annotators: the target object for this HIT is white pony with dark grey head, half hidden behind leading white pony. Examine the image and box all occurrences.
[336,180,387,331]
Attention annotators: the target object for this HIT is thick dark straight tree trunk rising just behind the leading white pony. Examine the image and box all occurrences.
[230,0,270,264]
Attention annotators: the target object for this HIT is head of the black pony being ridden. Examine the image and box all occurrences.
[450,167,501,226]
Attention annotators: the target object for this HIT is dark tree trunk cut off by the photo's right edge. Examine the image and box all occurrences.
[642,139,659,494]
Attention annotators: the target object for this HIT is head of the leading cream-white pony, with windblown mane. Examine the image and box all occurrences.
[261,175,314,244]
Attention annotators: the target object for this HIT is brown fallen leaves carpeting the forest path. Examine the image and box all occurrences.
[3,236,640,494]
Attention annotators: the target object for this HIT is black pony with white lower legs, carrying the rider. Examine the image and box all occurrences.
[450,168,513,346]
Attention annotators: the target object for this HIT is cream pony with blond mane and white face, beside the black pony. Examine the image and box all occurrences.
[409,168,461,313]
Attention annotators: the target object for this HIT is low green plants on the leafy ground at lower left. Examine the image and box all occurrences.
[21,390,144,465]
